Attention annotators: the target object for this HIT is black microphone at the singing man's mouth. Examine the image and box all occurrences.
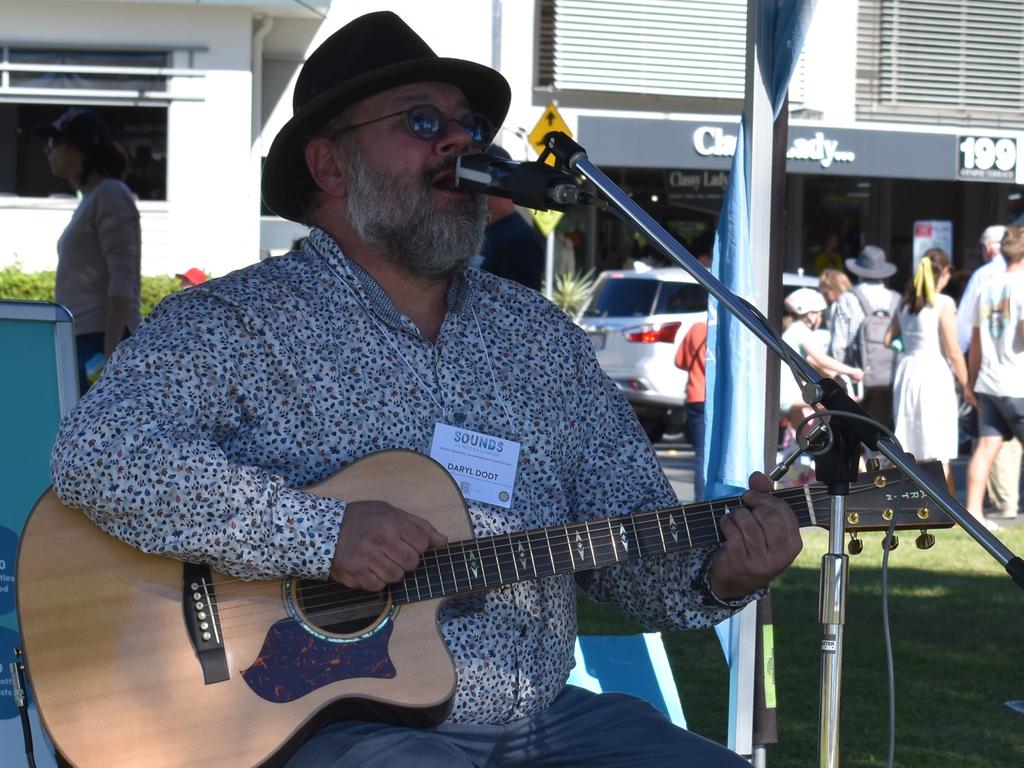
[455,154,607,211]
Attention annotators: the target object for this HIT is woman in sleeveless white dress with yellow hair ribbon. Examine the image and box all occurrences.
[886,248,977,493]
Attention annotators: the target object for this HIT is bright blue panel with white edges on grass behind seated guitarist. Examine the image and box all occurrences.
[568,632,686,728]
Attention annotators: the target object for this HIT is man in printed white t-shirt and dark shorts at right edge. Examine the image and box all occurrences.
[967,226,1024,527]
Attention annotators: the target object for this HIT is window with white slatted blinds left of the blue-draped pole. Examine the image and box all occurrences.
[537,0,746,105]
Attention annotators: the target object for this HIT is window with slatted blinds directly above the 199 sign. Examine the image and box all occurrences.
[857,0,1024,126]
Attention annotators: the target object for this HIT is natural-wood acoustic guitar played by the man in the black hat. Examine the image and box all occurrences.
[17,451,952,768]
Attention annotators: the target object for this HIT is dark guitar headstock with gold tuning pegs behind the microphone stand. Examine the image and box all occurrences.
[810,462,954,532]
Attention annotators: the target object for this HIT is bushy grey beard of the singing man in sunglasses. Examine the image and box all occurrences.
[347,142,487,280]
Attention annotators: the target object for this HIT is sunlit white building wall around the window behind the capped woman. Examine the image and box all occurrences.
[0,0,268,274]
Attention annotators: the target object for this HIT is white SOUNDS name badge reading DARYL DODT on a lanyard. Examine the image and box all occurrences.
[430,423,519,509]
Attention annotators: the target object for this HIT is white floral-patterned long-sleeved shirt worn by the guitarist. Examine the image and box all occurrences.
[52,229,757,724]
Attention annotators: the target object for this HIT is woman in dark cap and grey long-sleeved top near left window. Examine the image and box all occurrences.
[36,108,141,393]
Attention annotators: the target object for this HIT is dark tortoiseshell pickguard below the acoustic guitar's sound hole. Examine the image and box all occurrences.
[242,618,397,703]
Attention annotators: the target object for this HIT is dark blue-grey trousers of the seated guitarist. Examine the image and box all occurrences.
[287,685,750,768]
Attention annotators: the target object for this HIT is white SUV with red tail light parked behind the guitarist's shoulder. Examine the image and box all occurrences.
[577,267,818,441]
